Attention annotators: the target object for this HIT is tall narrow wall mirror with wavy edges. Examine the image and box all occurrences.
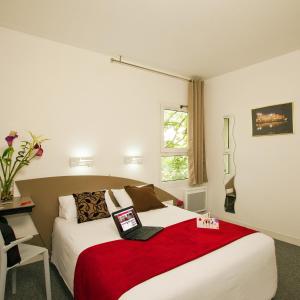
[223,116,236,213]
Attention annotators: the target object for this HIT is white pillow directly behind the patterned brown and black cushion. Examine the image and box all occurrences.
[58,191,119,222]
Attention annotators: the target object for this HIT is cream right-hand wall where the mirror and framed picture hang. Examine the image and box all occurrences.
[205,51,300,245]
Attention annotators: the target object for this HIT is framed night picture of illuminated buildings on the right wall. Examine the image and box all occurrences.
[252,102,293,136]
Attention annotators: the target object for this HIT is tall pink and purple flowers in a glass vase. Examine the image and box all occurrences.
[0,131,47,202]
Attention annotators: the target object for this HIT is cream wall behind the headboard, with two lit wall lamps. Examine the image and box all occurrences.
[0,28,187,197]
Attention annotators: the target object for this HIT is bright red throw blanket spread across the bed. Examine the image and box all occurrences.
[74,219,255,300]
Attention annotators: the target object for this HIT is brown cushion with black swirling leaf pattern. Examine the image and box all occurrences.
[73,191,110,223]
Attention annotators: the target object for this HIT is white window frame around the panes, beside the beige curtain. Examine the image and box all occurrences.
[159,105,188,183]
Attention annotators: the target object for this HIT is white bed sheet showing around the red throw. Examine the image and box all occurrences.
[51,206,277,300]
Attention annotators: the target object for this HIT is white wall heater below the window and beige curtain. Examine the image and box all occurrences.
[184,186,207,212]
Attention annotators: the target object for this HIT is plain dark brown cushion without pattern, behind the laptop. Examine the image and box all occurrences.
[124,184,166,212]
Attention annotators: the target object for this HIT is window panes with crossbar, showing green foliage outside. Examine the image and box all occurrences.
[161,108,188,181]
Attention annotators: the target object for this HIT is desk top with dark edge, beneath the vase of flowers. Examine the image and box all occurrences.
[0,197,35,216]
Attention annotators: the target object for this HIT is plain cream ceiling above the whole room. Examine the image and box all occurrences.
[0,0,300,78]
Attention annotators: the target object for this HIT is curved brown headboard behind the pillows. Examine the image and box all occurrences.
[16,176,176,251]
